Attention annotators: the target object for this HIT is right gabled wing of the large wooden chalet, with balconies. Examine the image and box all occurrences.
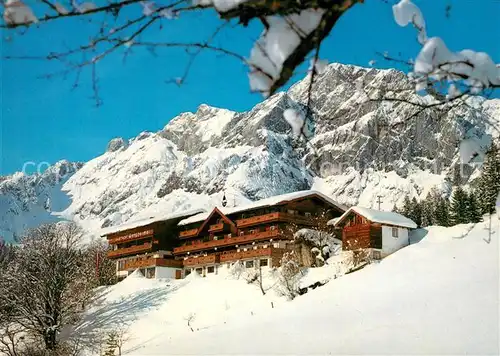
[173,191,345,275]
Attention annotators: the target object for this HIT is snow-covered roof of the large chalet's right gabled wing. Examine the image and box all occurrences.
[179,190,346,225]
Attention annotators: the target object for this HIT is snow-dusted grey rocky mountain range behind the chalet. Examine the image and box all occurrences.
[0,64,500,239]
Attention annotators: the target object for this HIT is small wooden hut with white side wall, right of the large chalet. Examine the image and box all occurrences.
[334,206,417,259]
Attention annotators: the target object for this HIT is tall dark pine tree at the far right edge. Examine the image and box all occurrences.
[478,144,500,215]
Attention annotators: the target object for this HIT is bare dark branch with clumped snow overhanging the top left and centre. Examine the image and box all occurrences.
[0,0,363,103]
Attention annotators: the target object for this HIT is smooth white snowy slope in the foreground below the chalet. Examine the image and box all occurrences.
[76,219,500,355]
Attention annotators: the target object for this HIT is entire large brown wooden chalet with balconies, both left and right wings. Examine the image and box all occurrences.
[102,191,345,278]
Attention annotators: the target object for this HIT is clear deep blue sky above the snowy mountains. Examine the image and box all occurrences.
[0,0,500,175]
